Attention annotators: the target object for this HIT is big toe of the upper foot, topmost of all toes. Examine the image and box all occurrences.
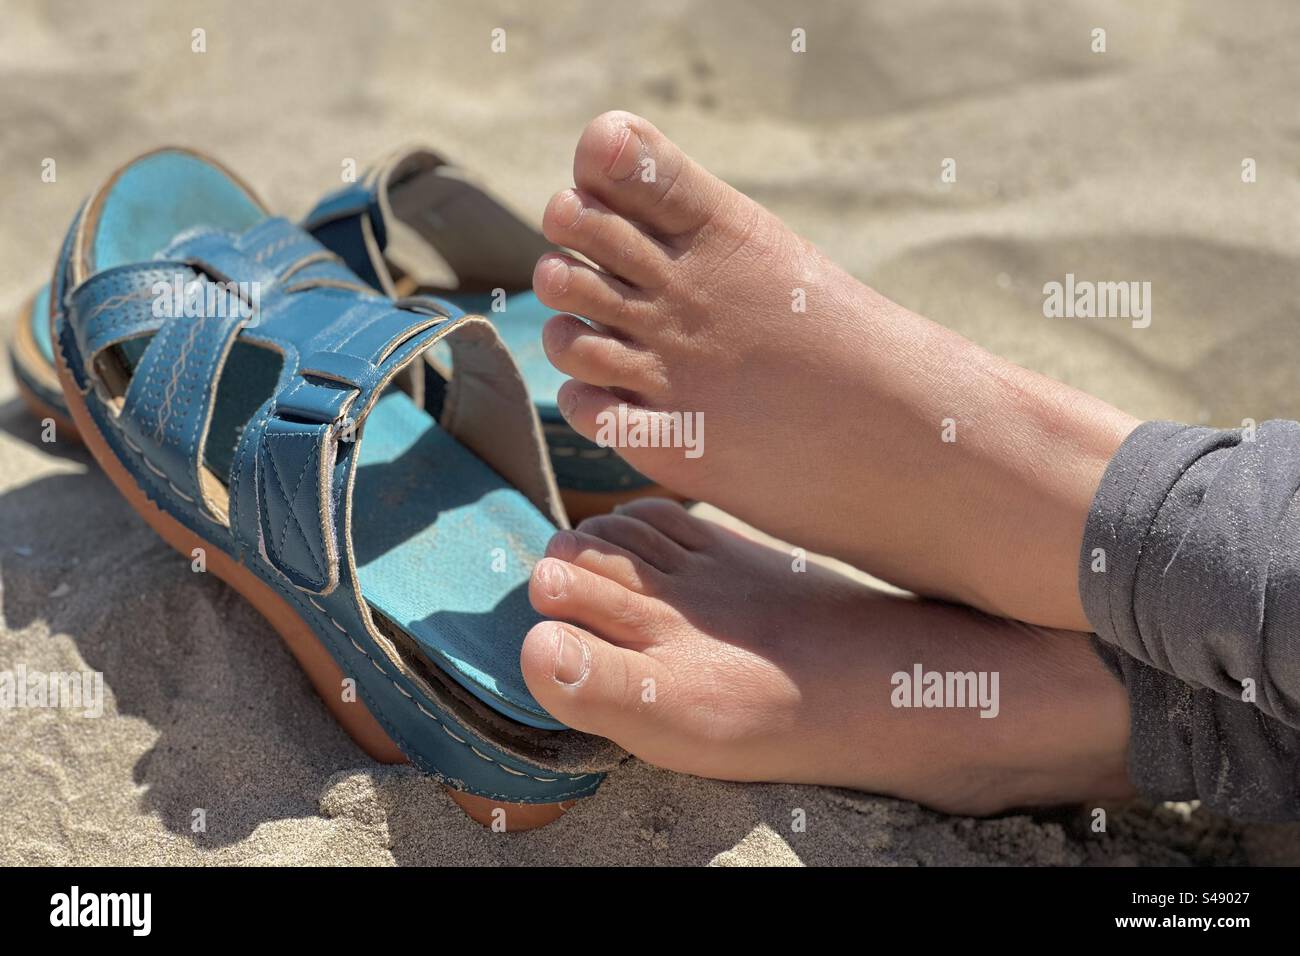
[573,112,728,239]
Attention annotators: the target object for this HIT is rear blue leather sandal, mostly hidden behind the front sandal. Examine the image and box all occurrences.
[303,148,673,519]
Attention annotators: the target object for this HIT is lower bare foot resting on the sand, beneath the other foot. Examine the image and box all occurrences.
[523,499,1130,813]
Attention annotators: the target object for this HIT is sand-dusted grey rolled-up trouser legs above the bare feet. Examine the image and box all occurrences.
[1079,421,1300,819]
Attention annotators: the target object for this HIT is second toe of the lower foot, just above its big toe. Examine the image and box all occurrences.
[528,558,672,648]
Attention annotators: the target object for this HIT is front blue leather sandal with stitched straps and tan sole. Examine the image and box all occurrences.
[51,150,621,830]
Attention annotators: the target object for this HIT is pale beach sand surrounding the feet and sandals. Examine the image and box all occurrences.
[0,0,1300,865]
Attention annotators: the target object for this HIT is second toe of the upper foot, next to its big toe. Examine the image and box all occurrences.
[542,189,672,289]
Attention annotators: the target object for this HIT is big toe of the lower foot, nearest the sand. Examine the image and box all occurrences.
[520,620,667,745]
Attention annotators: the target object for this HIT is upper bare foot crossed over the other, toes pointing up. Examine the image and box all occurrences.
[533,113,1135,628]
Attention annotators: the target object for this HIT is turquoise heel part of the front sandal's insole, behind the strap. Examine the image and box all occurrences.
[352,390,564,728]
